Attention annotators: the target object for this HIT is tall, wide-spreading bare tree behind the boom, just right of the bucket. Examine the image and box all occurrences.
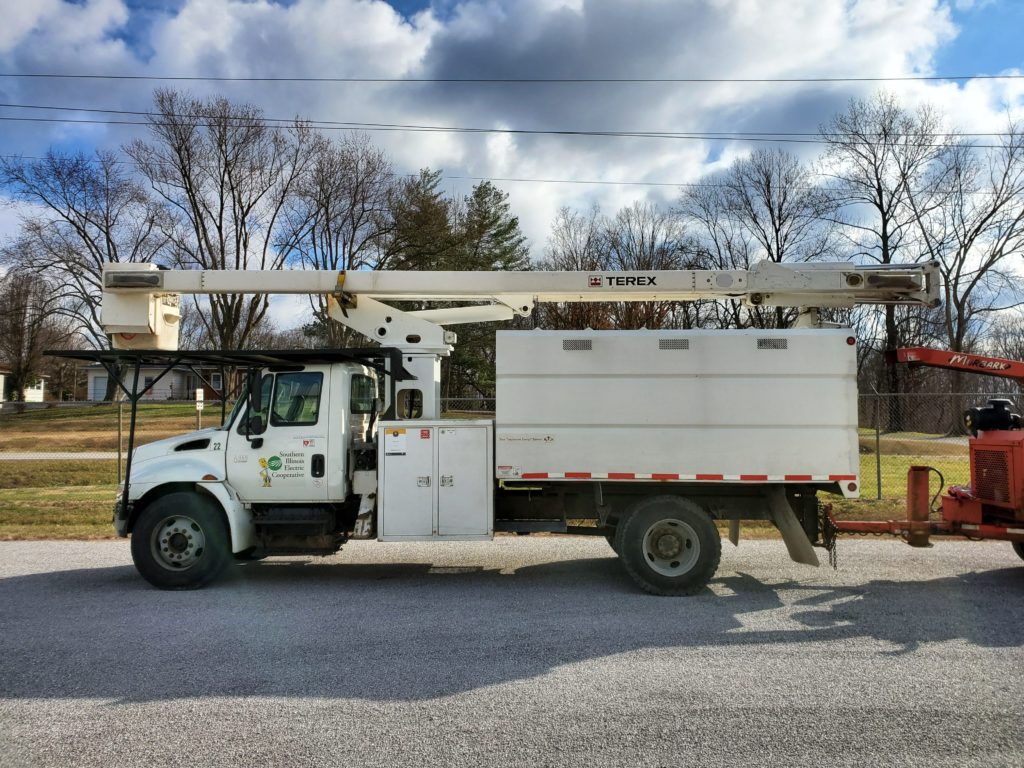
[125,89,313,348]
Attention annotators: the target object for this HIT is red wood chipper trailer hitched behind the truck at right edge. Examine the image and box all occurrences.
[828,347,1024,559]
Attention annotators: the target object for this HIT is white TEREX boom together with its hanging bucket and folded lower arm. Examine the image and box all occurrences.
[102,261,939,354]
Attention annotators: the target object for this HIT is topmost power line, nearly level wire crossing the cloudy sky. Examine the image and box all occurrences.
[0,72,1024,85]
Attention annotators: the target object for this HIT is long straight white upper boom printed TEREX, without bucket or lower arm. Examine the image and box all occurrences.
[103,261,938,307]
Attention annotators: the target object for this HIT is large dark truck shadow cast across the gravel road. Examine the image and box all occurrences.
[0,557,1024,701]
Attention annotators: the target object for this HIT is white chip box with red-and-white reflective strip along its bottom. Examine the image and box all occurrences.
[495,329,859,496]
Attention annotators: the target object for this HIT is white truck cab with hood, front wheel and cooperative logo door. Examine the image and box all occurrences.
[115,361,383,587]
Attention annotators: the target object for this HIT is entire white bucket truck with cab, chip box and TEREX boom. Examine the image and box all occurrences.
[51,262,938,595]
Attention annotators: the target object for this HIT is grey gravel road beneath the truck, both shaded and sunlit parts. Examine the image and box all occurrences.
[0,538,1024,768]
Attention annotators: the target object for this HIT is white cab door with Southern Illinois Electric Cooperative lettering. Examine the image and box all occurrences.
[227,366,331,504]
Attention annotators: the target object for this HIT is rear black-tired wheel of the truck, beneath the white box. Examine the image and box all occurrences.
[617,496,722,595]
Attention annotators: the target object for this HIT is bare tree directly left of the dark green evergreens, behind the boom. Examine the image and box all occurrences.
[280,134,394,347]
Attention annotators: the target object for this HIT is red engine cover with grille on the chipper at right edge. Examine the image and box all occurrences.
[970,430,1024,519]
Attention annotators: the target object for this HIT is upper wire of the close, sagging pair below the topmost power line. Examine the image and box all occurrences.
[0,102,1014,138]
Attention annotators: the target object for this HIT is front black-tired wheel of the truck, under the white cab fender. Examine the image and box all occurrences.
[131,492,231,590]
